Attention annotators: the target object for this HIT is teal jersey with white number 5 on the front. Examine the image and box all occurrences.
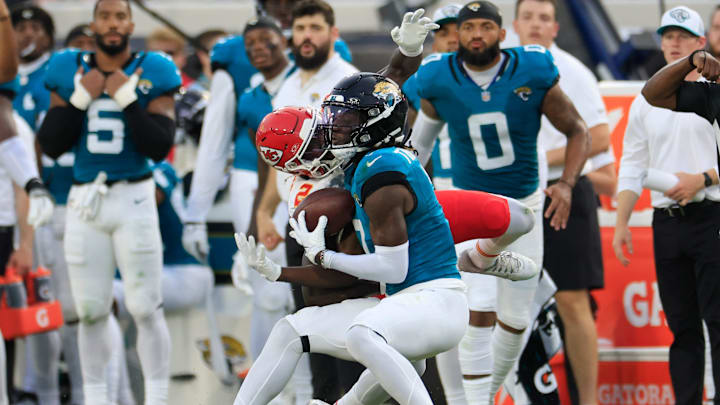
[45,49,181,183]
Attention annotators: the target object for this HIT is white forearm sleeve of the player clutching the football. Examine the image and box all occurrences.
[323,241,410,284]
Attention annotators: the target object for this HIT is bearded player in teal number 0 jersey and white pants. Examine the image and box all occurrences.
[413,1,589,404]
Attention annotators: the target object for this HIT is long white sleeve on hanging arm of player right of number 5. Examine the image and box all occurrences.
[185,70,236,222]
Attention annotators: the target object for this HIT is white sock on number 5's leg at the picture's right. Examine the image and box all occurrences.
[133,308,170,405]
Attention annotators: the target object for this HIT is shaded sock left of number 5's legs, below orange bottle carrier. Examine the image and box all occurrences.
[30,331,60,405]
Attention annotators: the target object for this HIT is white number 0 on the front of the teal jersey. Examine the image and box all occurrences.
[468,112,515,170]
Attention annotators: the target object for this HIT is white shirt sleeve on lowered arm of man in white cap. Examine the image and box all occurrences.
[617,95,650,195]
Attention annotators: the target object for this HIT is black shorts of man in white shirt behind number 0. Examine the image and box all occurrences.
[543,176,605,291]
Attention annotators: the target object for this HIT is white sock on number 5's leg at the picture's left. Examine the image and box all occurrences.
[78,317,111,405]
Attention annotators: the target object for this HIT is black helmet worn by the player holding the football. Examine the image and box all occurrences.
[317,72,408,164]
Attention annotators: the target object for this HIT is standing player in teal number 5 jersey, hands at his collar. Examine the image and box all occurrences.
[38,0,180,405]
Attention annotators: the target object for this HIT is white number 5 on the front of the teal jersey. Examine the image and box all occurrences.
[87,99,125,155]
